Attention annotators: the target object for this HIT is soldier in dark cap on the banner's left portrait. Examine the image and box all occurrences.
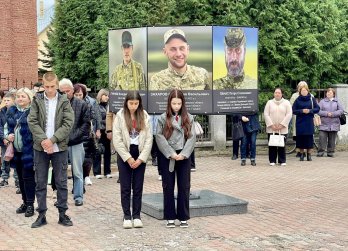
[110,31,146,90]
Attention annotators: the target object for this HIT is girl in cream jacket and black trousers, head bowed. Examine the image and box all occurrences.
[112,91,152,228]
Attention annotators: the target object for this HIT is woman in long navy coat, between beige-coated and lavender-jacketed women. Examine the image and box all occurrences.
[292,86,320,161]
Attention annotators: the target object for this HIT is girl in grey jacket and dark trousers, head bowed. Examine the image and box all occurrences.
[156,89,196,228]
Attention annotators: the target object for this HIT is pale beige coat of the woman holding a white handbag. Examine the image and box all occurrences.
[264,98,292,134]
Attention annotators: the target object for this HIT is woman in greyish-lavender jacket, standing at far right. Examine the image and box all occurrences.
[317,88,344,157]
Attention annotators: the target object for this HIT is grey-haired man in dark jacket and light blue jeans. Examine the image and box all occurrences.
[59,78,91,206]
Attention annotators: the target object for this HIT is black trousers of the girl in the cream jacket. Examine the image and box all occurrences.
[117,145,146,220]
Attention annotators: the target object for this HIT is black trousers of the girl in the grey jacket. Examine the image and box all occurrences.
[158,151,191,221]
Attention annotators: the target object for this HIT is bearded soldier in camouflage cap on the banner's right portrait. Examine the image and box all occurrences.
[213,28,257,90]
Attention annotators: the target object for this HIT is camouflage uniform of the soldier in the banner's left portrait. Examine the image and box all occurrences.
[110,60,146,90]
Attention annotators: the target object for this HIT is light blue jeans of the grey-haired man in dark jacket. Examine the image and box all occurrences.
[68,143,85,202]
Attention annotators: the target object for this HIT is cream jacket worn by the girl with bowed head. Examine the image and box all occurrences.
[112,109,153,163]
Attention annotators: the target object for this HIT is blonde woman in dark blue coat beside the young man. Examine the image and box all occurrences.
[4,87,36,217]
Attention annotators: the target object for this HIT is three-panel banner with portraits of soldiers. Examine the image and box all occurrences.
[109,26,258,114]
